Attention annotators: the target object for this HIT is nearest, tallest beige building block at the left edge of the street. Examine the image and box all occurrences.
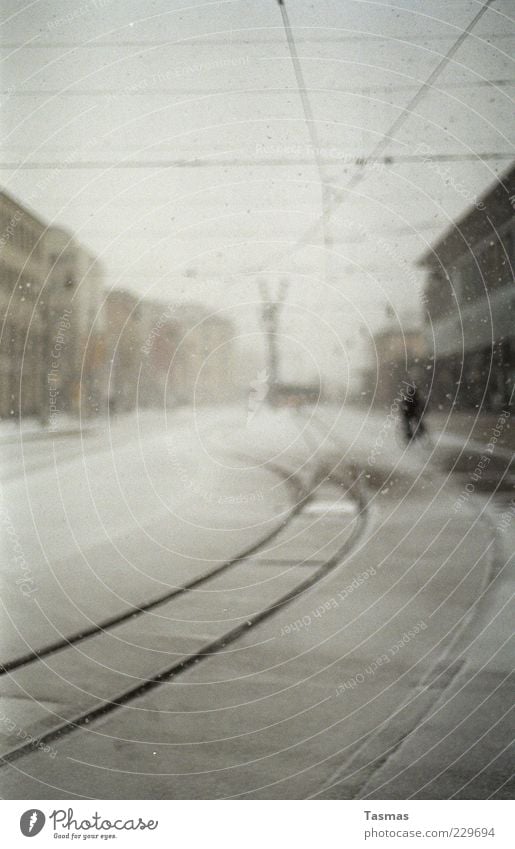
[0,192,105,425]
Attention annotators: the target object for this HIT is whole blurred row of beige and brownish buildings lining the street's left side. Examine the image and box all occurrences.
[0,192,235,420]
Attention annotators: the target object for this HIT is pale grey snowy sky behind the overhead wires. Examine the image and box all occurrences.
[1,0,515,382]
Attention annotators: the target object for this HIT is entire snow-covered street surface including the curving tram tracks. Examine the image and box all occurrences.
[0,409,507,798]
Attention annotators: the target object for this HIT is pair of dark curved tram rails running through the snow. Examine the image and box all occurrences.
[0,440,366,765]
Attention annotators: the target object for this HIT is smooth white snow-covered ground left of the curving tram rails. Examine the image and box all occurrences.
[0,412,318,664]
